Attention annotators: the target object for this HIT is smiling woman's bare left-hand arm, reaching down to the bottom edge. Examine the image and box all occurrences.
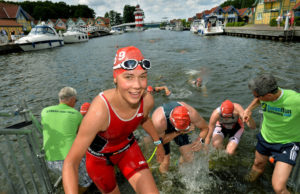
[62,96,109,194]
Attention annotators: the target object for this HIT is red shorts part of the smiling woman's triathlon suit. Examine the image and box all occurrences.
[86,141,149,193]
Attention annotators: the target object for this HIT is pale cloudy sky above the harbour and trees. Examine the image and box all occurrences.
[13,0,226,22]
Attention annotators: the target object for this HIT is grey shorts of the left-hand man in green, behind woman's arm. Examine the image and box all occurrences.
[47,158,93,187]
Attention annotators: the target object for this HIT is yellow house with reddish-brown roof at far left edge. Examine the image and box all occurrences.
[0,2,34,39]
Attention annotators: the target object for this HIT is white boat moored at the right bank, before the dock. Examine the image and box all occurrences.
[198,16,224,36]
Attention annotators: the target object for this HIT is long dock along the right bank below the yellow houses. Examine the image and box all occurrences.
[224,24,300,41]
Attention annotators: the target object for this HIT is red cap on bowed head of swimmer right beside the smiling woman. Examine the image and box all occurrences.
[170,106,191,131]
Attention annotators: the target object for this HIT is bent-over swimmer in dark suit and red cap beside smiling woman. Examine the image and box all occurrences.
[152,101,208,173]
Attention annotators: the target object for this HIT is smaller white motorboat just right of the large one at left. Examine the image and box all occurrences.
[63,28,89,43]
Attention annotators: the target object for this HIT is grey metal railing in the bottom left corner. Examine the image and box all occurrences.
[0,103,61,194]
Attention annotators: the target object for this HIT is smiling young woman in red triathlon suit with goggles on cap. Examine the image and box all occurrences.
[63,46,164,193]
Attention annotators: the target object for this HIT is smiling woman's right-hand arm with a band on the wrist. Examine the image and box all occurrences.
[142,93,165,163]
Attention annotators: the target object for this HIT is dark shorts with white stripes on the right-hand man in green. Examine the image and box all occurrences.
[256,133,300,166]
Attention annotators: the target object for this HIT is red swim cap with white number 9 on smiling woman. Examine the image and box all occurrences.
[113,46,144,78]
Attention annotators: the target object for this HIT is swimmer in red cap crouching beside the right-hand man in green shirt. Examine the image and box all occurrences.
[207,100,256,155]
